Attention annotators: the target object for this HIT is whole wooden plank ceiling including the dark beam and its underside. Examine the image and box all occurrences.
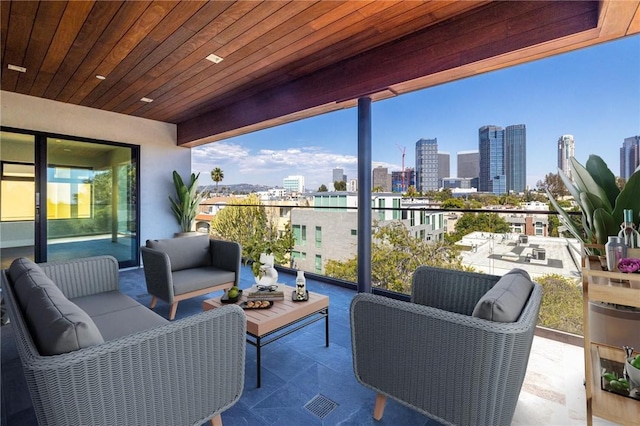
[0,0,640,146]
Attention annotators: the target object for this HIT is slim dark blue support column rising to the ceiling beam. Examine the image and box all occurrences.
[358,97,371,293]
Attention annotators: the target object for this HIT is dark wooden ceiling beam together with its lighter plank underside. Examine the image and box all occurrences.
[178,1,640,146]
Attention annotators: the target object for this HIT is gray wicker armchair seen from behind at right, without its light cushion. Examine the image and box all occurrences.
[351,266,542,425]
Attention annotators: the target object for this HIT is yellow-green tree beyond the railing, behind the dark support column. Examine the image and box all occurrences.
[325,222,470,293]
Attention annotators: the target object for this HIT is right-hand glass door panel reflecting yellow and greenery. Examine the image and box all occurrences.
[46,138,138,267]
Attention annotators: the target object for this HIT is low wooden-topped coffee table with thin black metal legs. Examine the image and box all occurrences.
[202,287,329,387]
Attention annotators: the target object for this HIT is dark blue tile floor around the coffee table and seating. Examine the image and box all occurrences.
[1,267,437,426]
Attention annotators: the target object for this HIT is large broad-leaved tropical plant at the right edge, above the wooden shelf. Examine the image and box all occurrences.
[546,155,640,251]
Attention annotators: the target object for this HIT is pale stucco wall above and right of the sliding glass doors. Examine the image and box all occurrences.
[0,91,191,250]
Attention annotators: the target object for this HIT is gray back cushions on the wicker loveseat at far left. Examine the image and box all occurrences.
[9,259,104,355]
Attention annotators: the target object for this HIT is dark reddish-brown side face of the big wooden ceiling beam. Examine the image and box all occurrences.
[178,1,600,146]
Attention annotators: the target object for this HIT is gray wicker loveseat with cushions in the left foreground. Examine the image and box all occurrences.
[2,256,246,426]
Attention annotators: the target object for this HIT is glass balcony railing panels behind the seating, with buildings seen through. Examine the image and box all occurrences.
[209,202,582,335]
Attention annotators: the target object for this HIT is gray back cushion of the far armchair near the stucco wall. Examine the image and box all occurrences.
[147,235,211,271]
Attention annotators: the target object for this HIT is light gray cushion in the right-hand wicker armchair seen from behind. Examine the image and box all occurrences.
[472,268,533,322]
